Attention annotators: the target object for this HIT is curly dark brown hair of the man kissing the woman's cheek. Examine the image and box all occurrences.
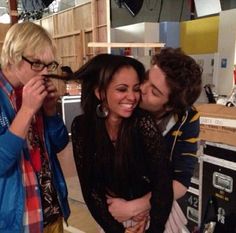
[151,48,202,113]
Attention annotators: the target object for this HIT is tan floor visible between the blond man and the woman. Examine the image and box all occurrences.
[59,142,99,233]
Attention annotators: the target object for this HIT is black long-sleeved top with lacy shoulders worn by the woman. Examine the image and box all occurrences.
[71,111,173,233]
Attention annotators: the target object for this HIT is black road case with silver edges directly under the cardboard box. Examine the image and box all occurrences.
[200,142,236,233]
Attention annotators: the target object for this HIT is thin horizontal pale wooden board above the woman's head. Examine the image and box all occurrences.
[88,42,165,48]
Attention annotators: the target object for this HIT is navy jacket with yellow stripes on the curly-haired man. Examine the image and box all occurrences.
[163,107,200,187]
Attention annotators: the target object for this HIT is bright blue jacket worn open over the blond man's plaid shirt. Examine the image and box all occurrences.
[0,72,70,233]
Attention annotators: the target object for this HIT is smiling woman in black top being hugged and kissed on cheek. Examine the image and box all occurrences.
[71,54,173,233]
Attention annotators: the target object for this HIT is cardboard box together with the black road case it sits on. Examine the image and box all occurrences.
[198,104,236,233]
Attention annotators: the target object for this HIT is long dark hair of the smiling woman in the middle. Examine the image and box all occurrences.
[75,54,145,196]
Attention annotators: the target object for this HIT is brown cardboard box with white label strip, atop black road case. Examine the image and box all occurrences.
[196,104,236,146]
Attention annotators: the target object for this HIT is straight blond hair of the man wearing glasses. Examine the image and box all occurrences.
[1,22,56,68]
